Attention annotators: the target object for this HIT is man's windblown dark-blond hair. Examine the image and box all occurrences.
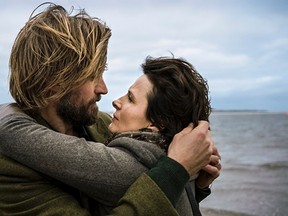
[10,4,111,112]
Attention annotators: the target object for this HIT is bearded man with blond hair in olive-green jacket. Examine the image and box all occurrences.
[0,5,221,215]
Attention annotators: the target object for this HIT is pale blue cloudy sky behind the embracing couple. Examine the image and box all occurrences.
[0,0,288,112]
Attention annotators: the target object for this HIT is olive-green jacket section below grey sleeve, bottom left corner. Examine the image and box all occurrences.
[0,155,90,216]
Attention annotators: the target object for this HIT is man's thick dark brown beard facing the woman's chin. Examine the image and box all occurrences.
[56,93,100,126]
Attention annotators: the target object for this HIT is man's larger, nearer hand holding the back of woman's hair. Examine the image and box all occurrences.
[168,121,214,176]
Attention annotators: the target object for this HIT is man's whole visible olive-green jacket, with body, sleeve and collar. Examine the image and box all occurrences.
[0,104,178,216]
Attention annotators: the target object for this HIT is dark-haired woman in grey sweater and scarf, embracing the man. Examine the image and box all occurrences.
[3,58,216,215]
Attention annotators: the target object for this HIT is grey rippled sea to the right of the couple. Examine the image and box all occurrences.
[200,112,288,216]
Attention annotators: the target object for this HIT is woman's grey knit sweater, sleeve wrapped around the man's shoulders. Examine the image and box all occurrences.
[0,104,194,215]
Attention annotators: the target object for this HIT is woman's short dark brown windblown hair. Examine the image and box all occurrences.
[142,57,211,147]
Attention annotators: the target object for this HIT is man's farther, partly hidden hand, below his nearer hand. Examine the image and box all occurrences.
[196,146,222,189]
